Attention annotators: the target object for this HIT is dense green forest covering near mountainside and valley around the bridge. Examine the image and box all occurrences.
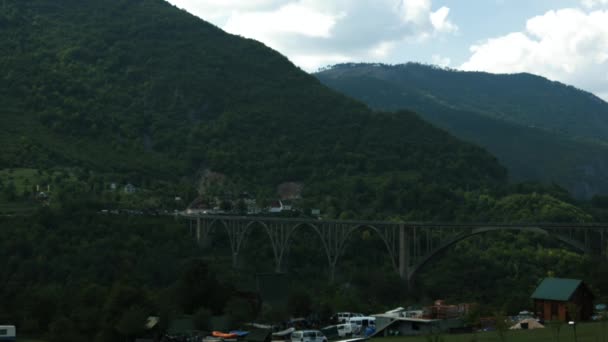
[0,0,608,342]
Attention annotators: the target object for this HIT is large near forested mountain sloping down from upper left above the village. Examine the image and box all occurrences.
[0,0,505,215]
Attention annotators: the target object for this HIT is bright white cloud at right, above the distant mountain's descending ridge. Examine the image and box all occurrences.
[460,8,608,99]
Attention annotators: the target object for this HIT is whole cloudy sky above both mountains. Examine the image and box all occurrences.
[169,0,608,100]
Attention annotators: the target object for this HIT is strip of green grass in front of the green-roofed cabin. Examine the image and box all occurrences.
[374,323,608,342]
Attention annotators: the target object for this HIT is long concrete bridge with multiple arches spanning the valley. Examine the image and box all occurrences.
[179,212,608,282]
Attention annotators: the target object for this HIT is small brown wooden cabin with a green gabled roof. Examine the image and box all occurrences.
[531,278,594,321]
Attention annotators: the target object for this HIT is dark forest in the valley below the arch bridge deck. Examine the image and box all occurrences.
[0,202,608,342]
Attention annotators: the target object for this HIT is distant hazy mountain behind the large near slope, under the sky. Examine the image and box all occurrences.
[316,63,608,198]
